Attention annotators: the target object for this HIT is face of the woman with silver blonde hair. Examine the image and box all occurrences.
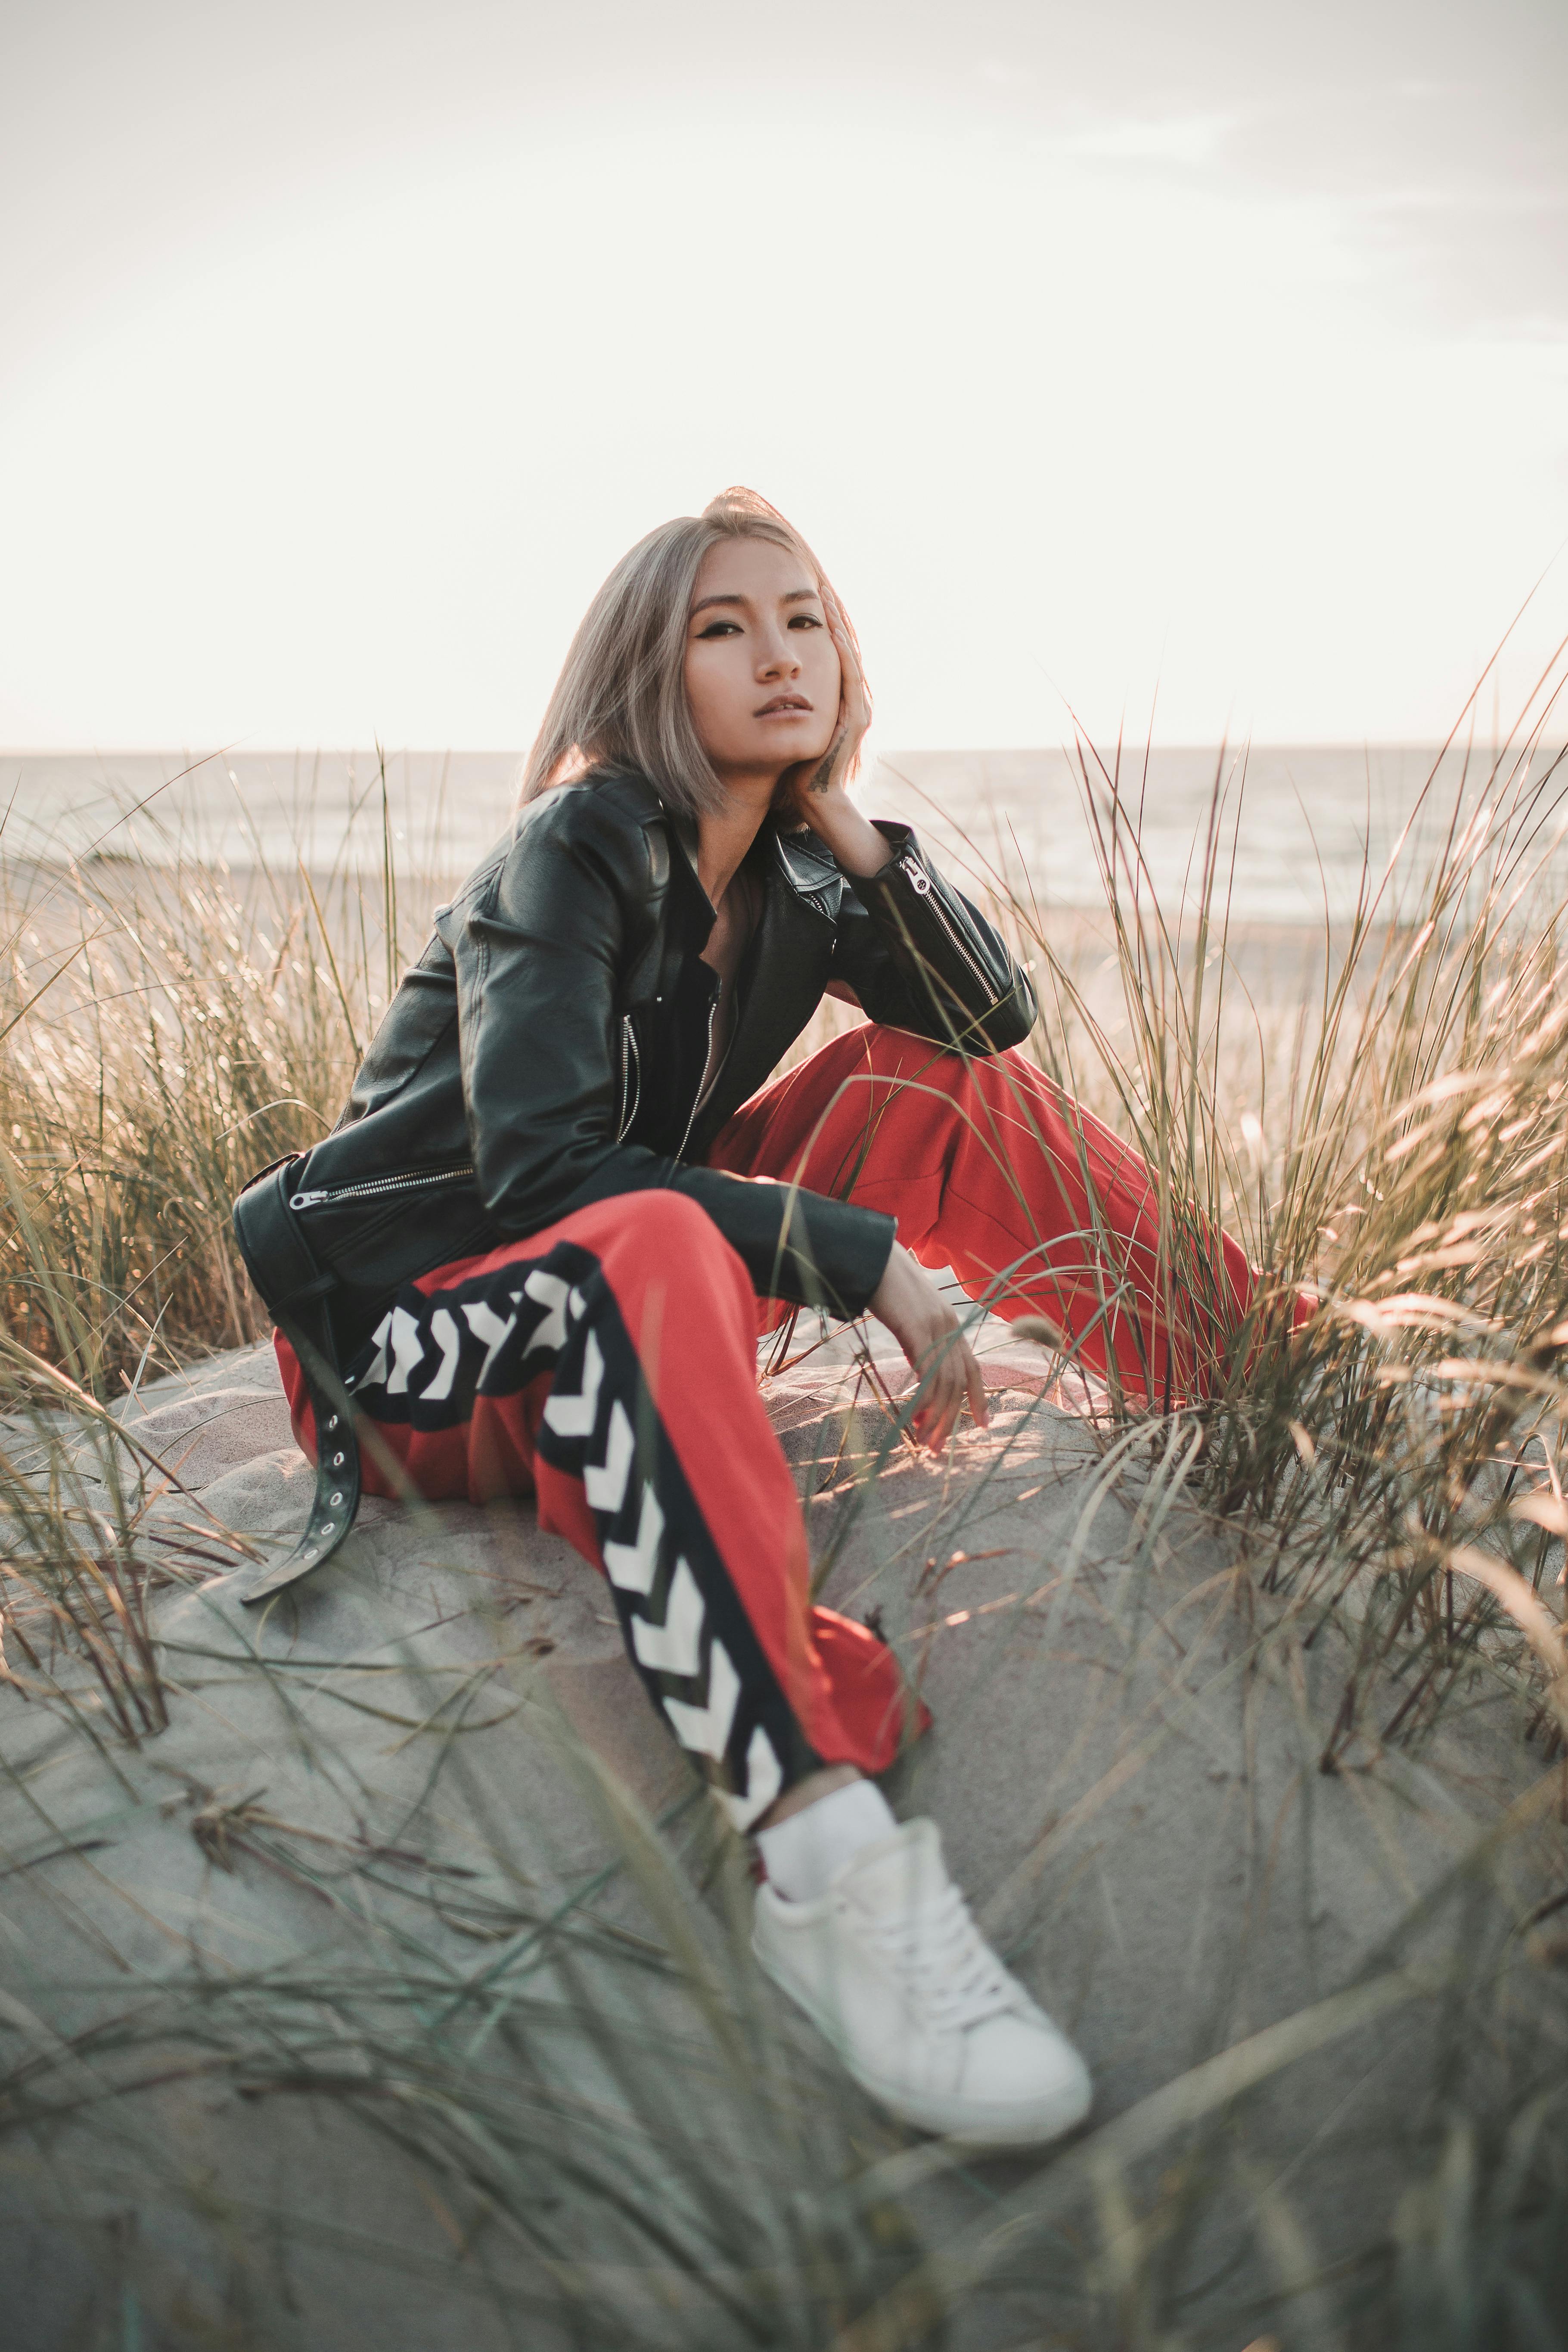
[686,539,839,783]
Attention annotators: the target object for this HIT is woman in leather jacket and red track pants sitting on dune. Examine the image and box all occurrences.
[237,492,1251,2143]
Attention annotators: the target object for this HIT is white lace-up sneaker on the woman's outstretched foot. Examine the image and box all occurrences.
[752,1821,1093,2147]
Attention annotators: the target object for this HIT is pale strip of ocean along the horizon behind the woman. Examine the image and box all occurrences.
[0,743,1568,925]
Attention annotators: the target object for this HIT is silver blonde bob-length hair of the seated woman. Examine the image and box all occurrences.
[519,487,854,816]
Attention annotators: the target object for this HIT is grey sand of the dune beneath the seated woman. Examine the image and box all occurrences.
[0,1327,1568,2352]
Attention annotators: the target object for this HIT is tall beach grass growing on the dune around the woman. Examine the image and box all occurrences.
[0,680,1568,2352]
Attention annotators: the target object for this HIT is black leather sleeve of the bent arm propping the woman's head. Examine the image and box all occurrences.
[832,819,1037,1054]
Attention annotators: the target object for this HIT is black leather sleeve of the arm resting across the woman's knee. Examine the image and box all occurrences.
[453,793,896,1315]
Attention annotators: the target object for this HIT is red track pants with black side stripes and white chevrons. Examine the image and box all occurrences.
[277,1025,1279,1828]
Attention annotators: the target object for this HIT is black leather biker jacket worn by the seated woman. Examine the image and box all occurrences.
[263,772,1034,1359]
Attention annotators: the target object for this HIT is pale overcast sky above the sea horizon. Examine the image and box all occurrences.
[0,0,1568,748]
